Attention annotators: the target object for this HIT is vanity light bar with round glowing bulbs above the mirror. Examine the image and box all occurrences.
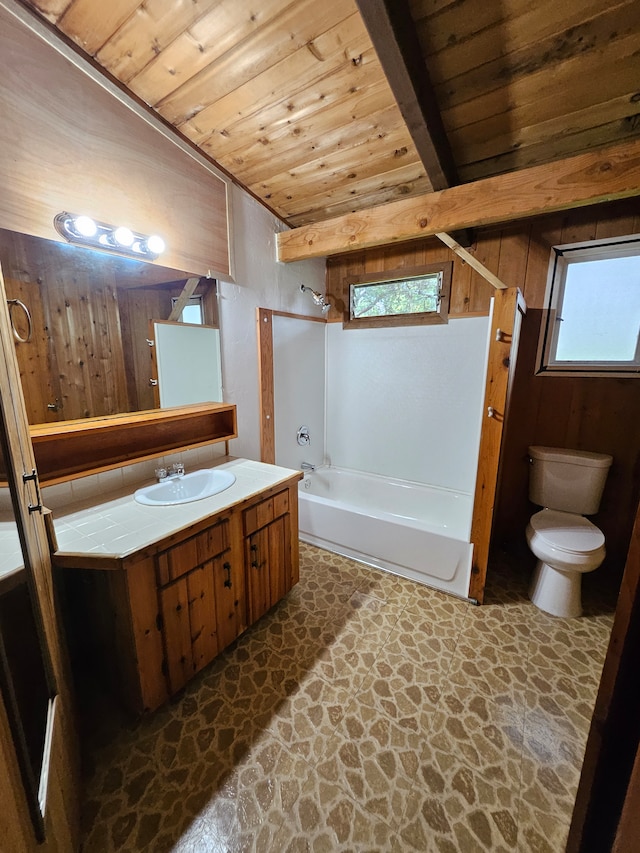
[53,211,166,261]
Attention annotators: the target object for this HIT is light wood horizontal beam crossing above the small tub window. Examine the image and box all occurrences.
[277,139,640,262]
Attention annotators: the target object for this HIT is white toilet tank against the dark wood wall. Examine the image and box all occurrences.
[529,446,613,515]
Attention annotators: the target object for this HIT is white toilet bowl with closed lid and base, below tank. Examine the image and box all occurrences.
[526,509,606,618]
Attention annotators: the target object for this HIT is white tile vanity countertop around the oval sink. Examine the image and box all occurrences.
[54,457,300,559]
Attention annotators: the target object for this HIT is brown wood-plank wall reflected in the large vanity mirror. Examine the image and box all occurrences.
[0,230,220,424]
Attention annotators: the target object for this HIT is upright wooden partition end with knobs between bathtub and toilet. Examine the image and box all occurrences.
[469,287,526,604]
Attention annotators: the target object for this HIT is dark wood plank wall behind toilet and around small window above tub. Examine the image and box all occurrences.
[327,201,640,583]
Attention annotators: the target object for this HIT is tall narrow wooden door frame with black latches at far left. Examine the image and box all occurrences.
[0,262,79,853]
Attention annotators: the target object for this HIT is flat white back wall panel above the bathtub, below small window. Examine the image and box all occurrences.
[326,317,489,493]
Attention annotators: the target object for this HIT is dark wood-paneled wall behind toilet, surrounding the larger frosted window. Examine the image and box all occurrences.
[495,202,640,583]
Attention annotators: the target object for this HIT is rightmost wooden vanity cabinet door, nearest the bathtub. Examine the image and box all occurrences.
[246,515,291,624]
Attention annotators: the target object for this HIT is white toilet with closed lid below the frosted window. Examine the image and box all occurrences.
[527,447,613,617]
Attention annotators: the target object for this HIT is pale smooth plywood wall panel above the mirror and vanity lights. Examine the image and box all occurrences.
[0,8,232,275]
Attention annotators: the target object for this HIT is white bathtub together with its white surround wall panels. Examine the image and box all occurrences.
[274,310,490,597]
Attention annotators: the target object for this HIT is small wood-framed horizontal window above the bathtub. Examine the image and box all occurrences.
[345,262,453,328]
